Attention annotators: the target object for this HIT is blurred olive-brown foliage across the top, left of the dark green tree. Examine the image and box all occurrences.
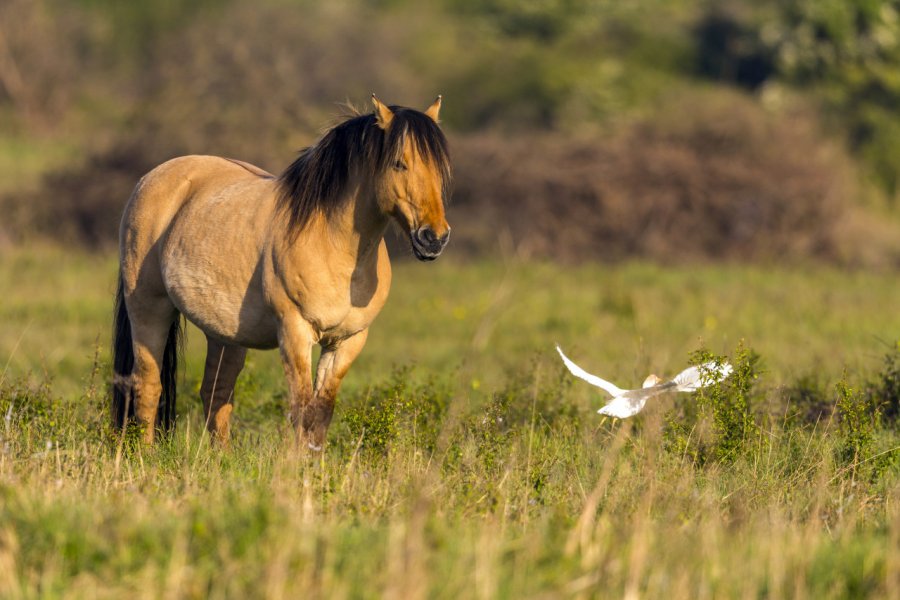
[0,0,694,136]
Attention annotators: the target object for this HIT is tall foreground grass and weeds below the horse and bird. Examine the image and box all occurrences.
[0,340,900,598]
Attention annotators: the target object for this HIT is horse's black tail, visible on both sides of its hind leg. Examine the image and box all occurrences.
[111,275,182,431]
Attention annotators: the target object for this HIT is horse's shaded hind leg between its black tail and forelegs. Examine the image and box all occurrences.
[200,336,247,446]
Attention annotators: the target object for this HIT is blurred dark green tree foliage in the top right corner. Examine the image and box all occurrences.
[696,0,900,198]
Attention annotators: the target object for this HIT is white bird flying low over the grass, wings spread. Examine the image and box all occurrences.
[556,346,734,419]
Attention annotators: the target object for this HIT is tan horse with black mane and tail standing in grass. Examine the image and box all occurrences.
[111,94,451,451]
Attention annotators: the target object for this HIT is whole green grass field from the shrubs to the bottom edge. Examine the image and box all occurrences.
[0,247,900,598]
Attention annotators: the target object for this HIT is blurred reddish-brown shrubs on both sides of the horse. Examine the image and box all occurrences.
[7,80,853,261]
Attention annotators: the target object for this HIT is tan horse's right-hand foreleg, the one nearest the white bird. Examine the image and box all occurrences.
[302,329,369,449]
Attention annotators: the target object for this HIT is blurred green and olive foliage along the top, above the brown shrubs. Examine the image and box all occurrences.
[0,0,900,154]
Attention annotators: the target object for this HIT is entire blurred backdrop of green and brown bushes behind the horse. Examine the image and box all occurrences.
[0,0,900,264]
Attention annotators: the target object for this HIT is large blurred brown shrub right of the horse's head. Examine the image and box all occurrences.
[452,92,852,261]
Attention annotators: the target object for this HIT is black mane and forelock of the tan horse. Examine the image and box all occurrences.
[278,106,451,232]
